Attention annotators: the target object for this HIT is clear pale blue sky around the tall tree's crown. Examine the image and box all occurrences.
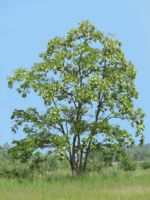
[0,0,150,144]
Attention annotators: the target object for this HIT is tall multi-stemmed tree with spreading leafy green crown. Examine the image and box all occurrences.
[8,21,144,176]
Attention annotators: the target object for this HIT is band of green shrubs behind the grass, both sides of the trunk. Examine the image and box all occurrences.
[0,145,150,177]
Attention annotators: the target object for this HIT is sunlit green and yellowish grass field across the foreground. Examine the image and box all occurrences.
[0,170,150,200]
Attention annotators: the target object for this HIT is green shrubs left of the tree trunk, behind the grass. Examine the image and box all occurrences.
[0,145,65,179]
